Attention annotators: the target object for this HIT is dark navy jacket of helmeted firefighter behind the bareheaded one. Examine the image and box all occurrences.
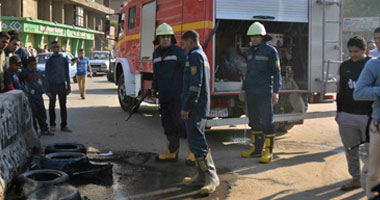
[152,45,186,103]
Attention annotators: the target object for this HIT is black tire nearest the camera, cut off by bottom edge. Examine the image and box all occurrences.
[27,185,82,200]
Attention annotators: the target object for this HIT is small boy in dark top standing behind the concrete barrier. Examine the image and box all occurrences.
[4,56,22,91]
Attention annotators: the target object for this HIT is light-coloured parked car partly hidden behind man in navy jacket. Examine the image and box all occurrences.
[37,52,77,83]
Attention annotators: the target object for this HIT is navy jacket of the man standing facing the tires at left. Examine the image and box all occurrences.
[45,55,71,92]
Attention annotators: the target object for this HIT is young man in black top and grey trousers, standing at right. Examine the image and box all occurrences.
[335,36,372,191]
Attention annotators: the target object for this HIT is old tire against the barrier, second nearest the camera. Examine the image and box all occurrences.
[17,169,69,196]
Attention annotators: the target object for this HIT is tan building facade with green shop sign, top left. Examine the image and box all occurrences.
[0,0,114,55]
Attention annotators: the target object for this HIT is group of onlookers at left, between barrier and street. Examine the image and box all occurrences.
[0,31,92,138]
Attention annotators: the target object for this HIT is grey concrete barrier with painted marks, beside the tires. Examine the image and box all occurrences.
[0,90,41,199]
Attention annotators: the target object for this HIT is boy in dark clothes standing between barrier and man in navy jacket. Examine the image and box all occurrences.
[22,57,54,135]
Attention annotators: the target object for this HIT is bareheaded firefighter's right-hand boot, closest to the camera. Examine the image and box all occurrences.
[197,151,220,195]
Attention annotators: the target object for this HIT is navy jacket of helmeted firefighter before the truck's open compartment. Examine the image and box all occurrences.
[242,42,281,94]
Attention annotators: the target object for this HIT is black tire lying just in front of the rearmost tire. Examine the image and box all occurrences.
[42,152,88,170]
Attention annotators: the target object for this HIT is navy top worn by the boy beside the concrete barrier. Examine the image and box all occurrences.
[22,68,45,102]
